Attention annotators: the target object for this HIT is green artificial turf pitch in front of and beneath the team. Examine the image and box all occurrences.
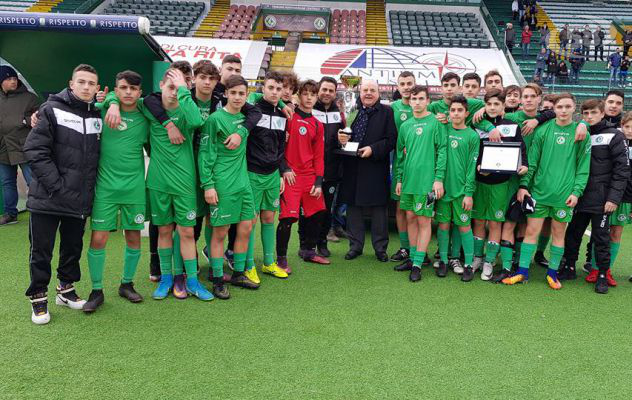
[0,214,632,399]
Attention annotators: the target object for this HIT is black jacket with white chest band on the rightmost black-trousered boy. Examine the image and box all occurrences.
[576,121,630,214]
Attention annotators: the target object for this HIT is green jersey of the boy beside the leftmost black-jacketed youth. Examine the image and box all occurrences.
[94,110,149,204]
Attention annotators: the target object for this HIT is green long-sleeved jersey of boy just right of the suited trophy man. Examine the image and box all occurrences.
[395,114,447,195]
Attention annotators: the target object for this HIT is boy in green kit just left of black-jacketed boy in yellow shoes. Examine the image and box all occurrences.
[198,75,259,299]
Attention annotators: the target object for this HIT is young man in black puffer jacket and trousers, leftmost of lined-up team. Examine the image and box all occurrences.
[24,64,103,324]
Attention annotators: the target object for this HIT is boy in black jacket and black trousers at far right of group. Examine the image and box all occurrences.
[558,99,630,293]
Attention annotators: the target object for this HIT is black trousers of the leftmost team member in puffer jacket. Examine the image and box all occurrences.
[26,213,86,296]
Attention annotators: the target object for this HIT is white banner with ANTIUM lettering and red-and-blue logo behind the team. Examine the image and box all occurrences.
[294,43,516,86]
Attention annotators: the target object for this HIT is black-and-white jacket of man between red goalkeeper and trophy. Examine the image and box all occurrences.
[312,101,346,182]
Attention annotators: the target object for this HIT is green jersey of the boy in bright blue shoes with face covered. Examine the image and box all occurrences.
[142,87,204,196]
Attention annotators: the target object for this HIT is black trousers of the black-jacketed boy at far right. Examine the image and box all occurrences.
[564,212,610,271]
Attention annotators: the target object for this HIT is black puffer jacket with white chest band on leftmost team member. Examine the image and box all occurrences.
[24,89,103,218]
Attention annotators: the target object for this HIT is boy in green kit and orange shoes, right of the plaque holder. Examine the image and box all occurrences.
[502,93,590,290]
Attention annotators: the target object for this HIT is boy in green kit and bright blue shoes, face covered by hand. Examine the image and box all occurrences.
[144,69,213,301]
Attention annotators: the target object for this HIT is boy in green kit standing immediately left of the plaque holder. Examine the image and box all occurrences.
[435,95,479,282]
